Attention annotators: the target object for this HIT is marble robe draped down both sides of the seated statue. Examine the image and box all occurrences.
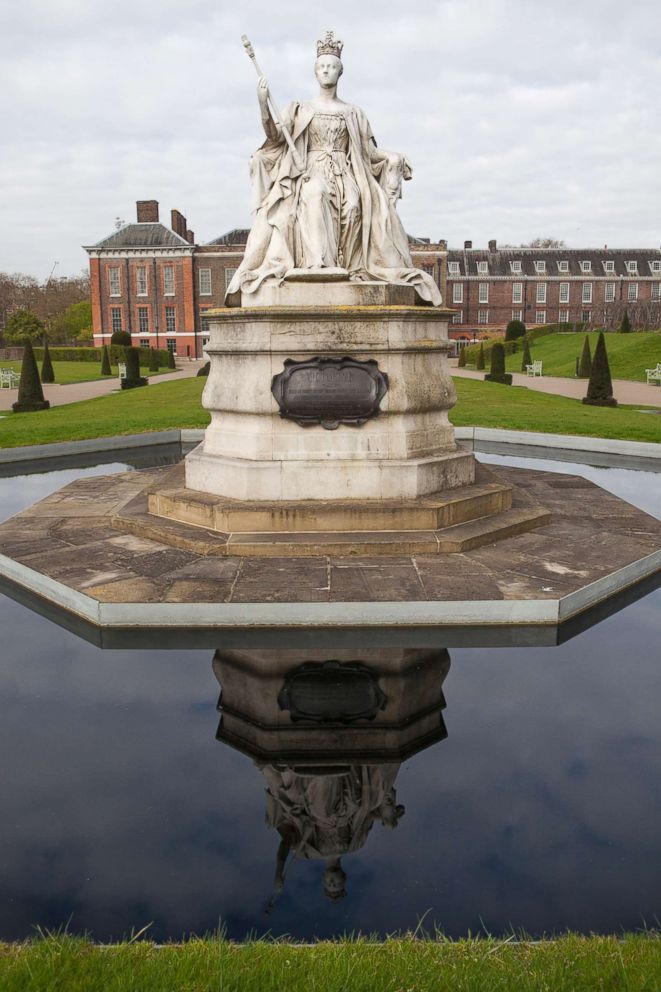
[227,103,441,306]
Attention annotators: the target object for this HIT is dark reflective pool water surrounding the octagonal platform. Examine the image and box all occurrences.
[0,457,661,940]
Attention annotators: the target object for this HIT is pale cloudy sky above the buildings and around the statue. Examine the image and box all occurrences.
[0,0,661,278]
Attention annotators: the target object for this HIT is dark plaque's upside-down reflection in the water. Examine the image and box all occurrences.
[278,661,386,724]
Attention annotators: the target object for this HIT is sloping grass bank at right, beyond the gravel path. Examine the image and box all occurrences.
[496,331,661,382]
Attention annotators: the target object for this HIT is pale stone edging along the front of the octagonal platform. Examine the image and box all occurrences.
[0,550,661,630]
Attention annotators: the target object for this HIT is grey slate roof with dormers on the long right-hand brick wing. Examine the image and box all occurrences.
[448,248,661,280]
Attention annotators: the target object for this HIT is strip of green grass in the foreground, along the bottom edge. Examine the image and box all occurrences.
[0,935,661,992]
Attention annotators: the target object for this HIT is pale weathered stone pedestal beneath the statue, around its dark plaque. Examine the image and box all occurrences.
[186,282,475,503]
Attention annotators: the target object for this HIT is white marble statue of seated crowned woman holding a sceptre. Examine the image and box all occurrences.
[228,32,441,306]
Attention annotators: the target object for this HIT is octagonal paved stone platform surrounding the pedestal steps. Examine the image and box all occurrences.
[0,458,661,647]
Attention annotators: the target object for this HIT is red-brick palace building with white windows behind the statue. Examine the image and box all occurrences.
[85,200,661,358]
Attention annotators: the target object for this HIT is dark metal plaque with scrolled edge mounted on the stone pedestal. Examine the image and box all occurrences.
[271,357,388,430]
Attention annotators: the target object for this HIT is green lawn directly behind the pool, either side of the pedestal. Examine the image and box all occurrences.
[0,377,661,448]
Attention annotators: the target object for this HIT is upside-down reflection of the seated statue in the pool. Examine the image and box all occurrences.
[259,764,404,900]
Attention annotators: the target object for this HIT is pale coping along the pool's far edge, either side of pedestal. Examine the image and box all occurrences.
[0,427,661,464]
